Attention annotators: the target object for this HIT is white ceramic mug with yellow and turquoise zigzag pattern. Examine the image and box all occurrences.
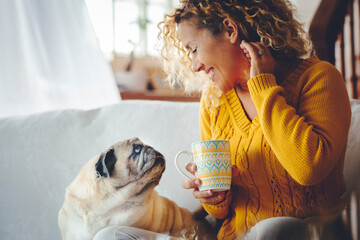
[175,140,232,192]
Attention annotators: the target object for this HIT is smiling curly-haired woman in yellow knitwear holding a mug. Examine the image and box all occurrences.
[160,0,351,239]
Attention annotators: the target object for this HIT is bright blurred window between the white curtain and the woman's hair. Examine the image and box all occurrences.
[85,0,179,56]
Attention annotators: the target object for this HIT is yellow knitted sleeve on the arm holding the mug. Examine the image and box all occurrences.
[199,94,231,219]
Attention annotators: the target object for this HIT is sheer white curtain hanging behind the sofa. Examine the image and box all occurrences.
[0,0,120,117]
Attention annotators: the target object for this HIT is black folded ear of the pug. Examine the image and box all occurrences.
[95,149,116,178]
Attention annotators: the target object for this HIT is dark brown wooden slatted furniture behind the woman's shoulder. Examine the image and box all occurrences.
[309,0,360,98]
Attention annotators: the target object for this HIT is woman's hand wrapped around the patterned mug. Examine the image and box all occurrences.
[182,162,239,205]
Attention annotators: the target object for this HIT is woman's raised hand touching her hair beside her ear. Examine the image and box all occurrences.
[240,40,276,78]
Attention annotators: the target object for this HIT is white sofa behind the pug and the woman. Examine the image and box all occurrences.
[0,100,360,240]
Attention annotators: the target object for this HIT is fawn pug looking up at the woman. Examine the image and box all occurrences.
[58,138,212,240]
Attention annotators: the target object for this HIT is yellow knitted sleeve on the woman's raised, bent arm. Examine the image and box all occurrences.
[248,62,351,186]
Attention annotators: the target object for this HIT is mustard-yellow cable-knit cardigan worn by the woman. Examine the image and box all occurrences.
[200,56,351,239]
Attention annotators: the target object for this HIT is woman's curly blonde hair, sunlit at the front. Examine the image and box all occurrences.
[158,0,312,96]
